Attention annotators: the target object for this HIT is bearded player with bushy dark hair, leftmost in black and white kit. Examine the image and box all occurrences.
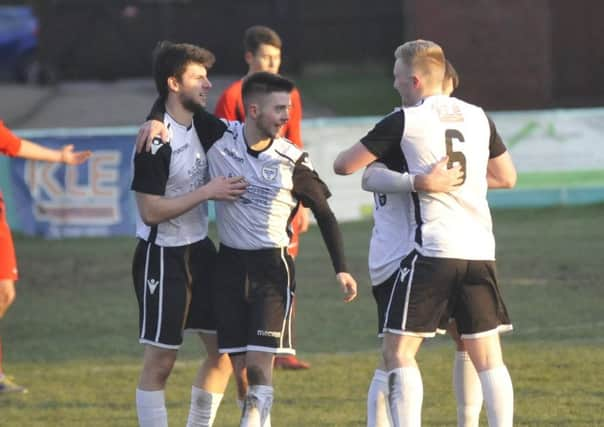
[132,43,246,427]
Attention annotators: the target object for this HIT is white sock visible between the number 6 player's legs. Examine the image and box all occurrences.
[453,351,482,427]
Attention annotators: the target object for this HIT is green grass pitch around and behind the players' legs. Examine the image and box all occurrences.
[0,205,604,427]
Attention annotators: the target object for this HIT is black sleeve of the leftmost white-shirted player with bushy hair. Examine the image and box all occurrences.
[130,144,172,196]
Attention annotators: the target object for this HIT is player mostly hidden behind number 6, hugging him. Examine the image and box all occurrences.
[362,61,496,427]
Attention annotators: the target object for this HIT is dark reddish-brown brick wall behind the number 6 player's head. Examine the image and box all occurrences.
[405,0,552,109]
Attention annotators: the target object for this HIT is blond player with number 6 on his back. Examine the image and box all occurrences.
[334,40,516,426]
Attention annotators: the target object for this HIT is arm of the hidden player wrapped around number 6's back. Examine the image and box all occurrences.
[362,157,463,193]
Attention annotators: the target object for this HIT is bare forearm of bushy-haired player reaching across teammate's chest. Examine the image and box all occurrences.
[136,176,248,225]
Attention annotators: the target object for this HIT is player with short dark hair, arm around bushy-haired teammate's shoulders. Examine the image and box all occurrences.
[142,72,357,427]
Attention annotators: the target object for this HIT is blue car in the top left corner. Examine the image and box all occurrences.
[0,6,40,82]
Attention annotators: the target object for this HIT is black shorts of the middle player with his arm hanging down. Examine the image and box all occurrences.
[214,244,295,354]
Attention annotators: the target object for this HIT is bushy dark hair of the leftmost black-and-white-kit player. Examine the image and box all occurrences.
[153,40,215,99]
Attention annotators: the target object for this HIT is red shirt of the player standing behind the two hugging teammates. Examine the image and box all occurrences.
[214,80,303,148]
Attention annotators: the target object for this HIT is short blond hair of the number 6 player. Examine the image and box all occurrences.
[394,39,446,85]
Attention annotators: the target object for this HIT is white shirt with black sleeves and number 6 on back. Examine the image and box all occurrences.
[361,95,506,260]
